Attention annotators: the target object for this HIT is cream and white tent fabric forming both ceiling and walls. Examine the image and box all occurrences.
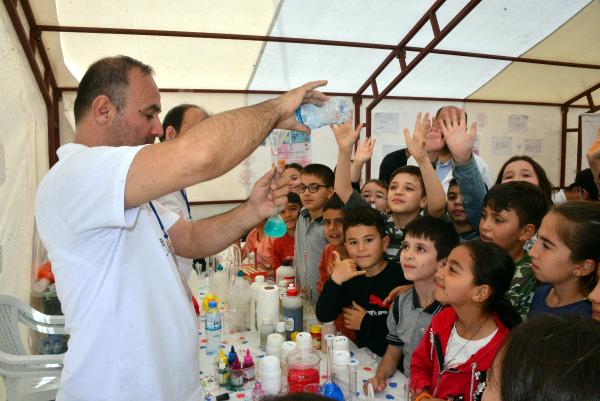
[0,4,600,386]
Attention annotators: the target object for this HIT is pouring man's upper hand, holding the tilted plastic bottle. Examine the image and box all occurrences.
[275,81,329,133]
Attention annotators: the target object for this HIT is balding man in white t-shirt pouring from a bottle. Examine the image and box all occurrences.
[36,56,326,401]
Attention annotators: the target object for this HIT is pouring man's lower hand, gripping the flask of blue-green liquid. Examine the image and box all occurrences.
[248,166,289,220]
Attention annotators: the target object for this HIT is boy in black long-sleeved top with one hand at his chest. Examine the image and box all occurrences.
[317,207,410,356]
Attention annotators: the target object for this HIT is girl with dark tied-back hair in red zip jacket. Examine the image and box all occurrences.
[410,241,521,401]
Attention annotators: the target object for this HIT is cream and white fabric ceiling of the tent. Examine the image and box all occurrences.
[22,0,600,108]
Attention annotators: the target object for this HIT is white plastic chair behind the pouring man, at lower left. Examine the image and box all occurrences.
[0,295,66,401]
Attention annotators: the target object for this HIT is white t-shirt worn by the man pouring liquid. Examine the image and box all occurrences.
[36,144,201,401]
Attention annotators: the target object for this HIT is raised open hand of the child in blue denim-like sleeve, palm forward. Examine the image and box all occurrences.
[439,108,477,165]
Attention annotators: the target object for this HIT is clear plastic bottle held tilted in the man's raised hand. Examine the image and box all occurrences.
[294,97,352,129]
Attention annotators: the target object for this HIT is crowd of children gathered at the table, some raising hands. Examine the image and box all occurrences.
[239,107,600,401]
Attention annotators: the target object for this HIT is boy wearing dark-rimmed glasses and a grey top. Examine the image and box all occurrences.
[294,164,334,304]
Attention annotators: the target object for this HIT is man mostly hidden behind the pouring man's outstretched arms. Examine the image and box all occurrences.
[158,103,208,280]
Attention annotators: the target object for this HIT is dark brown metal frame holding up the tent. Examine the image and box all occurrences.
[3,0,600,188]
